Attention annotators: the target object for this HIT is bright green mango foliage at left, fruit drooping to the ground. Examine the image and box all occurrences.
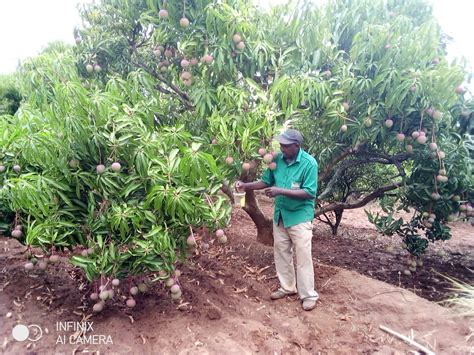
[0,48,235,311]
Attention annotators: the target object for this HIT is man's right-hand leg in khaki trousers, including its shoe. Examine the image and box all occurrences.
[288,222,319,310]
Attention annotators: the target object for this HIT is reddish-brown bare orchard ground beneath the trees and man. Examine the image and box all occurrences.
[0,197,474,354]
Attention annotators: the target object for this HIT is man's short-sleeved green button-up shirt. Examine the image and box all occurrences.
[262,149,318,228]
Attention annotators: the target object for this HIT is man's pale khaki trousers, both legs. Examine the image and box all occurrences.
[273,222,318,300]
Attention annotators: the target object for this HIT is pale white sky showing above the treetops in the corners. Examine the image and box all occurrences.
[0,0,474,80]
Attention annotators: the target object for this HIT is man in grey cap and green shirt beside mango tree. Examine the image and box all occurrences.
[236,129,319,311]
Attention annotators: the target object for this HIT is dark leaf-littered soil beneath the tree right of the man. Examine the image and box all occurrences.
[322,206,474,302]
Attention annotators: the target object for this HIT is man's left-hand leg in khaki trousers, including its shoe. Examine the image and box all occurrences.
[272,223,296,299]
